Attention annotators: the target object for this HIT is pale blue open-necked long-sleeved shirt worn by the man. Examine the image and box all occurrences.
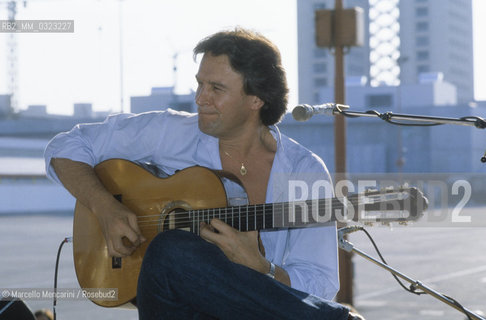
[45,109,339,300]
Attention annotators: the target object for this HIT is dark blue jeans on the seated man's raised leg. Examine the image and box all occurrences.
[137,230,348,320]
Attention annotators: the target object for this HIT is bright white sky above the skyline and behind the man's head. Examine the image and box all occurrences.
[0,0,486,114]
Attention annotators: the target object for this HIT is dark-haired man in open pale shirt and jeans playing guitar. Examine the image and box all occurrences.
[46,29,358,319]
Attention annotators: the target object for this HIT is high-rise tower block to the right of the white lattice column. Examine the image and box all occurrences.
[400,0,474,103]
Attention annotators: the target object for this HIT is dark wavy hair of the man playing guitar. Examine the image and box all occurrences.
[194,28,289,126]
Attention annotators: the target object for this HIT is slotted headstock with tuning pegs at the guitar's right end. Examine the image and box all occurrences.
[350,187,428,224]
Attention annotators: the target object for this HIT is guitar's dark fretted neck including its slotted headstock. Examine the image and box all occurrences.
[164,188,427,234]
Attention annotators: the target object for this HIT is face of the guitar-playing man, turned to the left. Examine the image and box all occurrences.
[196,53,263,138]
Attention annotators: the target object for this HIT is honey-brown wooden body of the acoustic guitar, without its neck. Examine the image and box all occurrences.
[73,159,242,307]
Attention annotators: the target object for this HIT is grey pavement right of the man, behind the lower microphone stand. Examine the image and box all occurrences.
[350,208,486,320]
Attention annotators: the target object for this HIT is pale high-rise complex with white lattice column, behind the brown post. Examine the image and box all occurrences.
[297,0,474,104]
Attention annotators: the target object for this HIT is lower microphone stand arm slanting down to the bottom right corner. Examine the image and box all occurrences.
[338,228,486,320]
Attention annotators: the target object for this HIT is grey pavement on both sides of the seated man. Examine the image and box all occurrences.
[0,208,486,320]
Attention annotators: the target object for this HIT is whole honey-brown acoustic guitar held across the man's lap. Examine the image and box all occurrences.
[73,159,427,307]
